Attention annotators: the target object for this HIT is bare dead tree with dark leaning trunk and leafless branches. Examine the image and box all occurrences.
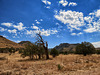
[36,33,49,59]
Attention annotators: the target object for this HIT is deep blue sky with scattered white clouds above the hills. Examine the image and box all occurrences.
[0,0,100,48]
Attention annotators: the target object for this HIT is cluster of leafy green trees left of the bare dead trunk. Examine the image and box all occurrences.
[19,43,45,60]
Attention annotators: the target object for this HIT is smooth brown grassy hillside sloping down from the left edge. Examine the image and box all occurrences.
[0,35,22,48]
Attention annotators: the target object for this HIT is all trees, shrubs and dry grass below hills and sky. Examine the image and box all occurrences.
[0,34,100,75]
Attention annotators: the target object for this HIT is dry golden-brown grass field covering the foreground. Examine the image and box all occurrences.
[0,53,100,75]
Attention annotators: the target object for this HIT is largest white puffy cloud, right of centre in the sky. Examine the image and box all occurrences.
[54,10,84,31]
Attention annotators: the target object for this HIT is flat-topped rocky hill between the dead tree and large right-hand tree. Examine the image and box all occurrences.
[54,43,78,52]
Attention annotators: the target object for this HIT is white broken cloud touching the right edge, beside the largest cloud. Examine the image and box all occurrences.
[84,9,100,33]
